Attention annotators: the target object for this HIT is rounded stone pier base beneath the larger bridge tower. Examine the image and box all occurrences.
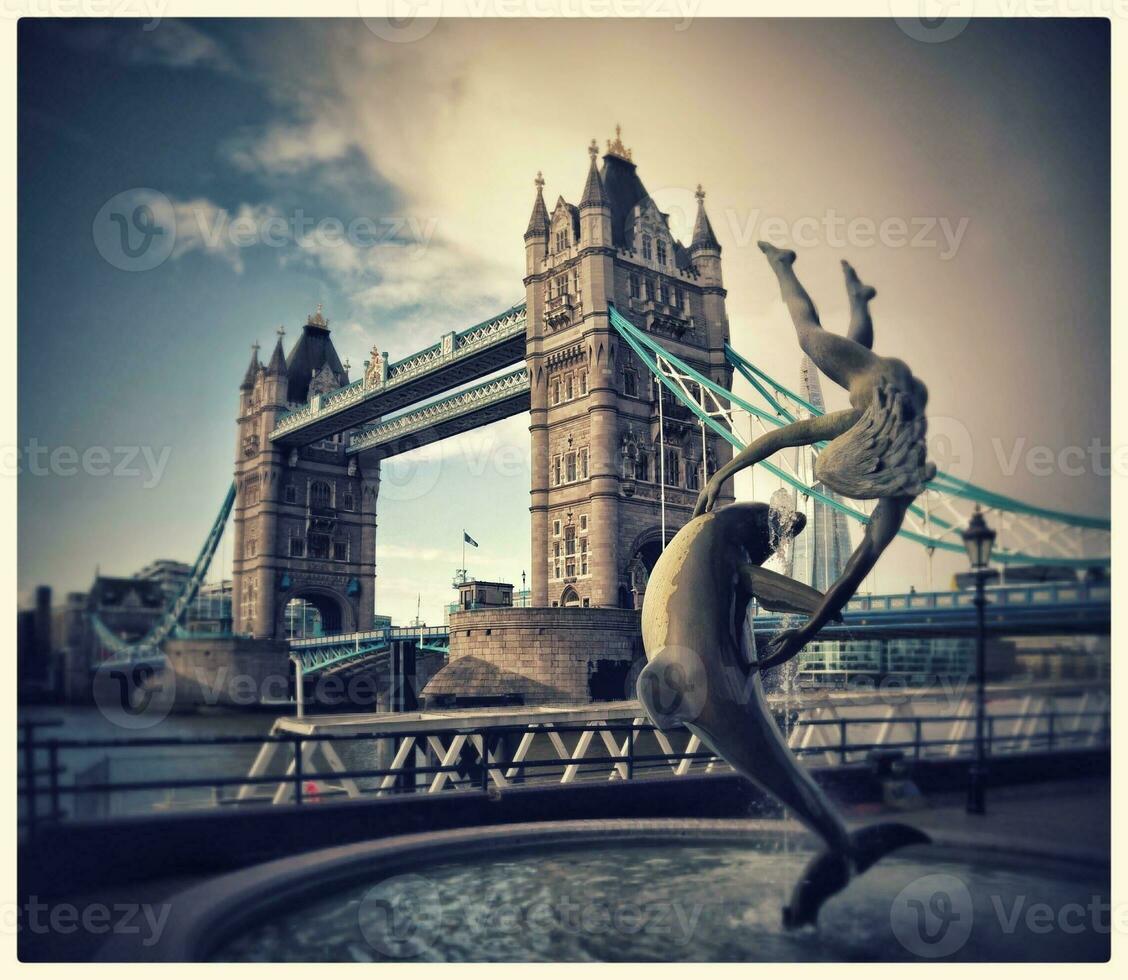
[422,607,644,708]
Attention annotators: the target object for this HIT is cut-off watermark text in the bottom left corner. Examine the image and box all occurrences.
[0,895,173,946]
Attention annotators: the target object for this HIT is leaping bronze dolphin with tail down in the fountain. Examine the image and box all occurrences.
[637,503,928,928]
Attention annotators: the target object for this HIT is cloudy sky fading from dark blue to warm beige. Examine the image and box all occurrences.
[17,18,1110,621]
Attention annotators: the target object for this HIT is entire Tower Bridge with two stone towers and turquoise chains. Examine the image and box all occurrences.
[87,127,1109,700]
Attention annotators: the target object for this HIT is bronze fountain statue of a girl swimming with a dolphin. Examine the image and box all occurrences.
[637,242,935,927]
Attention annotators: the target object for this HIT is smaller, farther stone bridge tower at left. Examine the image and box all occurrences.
[231,307,380,639]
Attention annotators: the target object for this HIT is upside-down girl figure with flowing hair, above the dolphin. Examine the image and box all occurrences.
[694,241,936,670]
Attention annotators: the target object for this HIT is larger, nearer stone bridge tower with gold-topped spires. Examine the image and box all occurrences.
[525,127,732,608]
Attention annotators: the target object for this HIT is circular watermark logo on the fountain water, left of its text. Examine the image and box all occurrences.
[356,874,442,960]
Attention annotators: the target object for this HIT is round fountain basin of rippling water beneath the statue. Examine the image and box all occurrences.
[103,820,1110,962]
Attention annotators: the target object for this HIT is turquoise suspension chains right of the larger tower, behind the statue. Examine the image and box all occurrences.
[609,307,1110,567]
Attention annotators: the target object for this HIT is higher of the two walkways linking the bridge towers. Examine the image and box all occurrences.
[270,302,526,448]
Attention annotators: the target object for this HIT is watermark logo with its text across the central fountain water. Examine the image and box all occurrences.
[356,874,705,960]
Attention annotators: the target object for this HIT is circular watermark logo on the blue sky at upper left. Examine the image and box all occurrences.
[92,187,176,272]
